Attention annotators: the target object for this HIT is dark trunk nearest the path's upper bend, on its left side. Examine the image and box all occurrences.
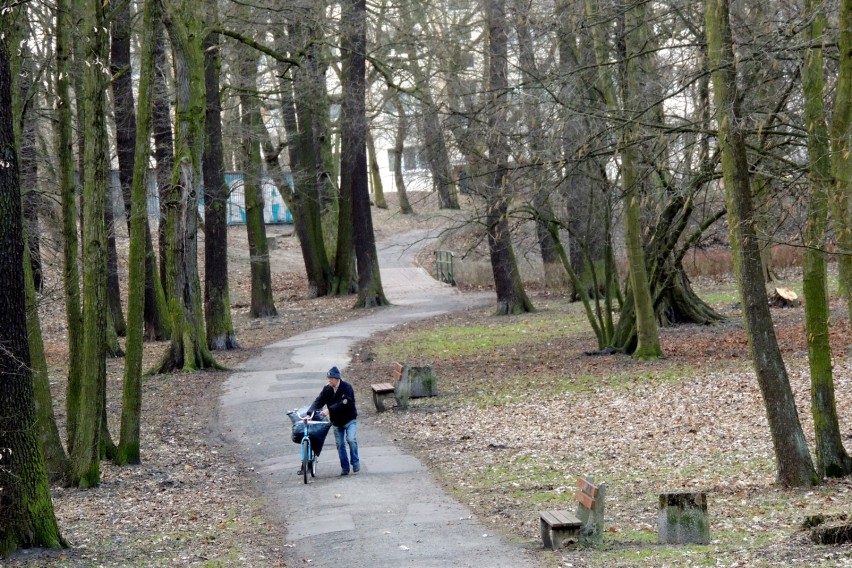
[338,0,388,307]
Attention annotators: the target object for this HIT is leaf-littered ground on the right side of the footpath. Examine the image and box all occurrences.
[342,283,852,567]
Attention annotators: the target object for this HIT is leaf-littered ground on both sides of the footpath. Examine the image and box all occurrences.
[3,193,852,567]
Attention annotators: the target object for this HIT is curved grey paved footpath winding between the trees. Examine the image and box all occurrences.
[213,232,533,568]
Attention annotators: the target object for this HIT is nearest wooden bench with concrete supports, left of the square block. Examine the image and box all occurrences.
[539,477,606,550]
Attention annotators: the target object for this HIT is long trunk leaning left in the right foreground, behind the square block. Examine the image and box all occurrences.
[705,0,819,487]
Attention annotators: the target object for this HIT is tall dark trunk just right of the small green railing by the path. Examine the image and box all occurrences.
[486,0,534,314]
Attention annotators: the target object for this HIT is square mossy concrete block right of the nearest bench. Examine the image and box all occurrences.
[657,492,710,544]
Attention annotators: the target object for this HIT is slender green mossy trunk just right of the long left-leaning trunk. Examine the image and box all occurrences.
[802,0,852,477]
